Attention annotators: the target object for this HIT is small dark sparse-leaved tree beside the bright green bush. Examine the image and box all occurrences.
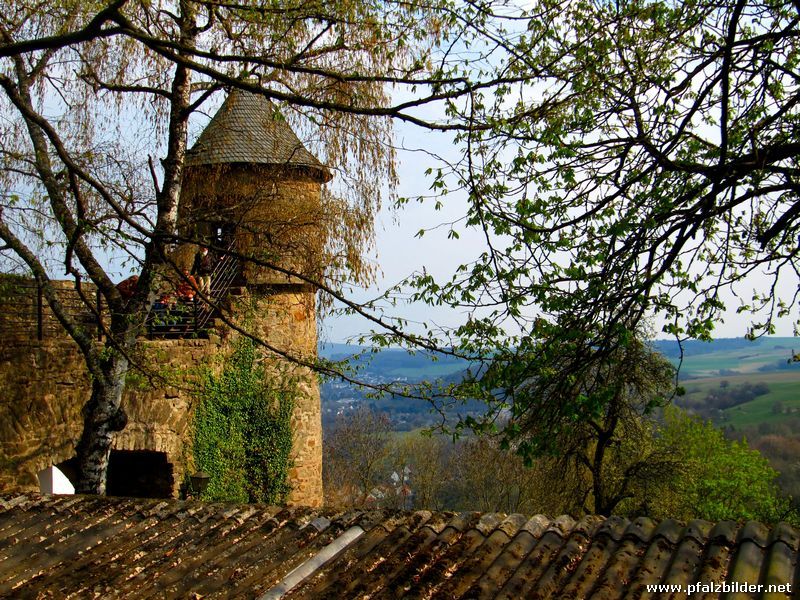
[532,340,680,515]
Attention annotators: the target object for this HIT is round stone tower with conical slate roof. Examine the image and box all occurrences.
[178,90,331,505]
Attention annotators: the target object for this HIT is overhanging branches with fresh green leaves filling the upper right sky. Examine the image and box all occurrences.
[368,0,800,454]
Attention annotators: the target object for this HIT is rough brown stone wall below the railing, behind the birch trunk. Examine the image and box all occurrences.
[0,324,212,494]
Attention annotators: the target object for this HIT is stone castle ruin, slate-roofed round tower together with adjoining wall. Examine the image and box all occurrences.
[0,90,332,506]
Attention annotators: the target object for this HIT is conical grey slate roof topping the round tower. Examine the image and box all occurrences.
[186,89,330,180]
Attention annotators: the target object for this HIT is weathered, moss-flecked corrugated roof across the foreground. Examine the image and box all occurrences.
[0,495,800,600]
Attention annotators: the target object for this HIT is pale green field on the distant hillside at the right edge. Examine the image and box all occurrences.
[682,370,800,428]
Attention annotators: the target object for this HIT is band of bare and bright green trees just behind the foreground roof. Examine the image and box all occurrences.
[323,406,800,524]
